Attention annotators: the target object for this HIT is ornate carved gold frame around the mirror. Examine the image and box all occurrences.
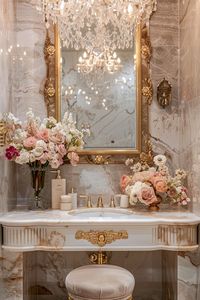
[44,25,153,164]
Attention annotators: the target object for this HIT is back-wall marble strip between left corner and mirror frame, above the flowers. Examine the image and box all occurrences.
[12,0,46,119]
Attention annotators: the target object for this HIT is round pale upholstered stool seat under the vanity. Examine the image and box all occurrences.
[65,265,135,300]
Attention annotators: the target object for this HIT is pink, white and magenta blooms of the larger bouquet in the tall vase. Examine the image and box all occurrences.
[5,109,87,169]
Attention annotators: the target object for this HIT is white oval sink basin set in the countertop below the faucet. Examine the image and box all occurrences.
[69,208,133,219]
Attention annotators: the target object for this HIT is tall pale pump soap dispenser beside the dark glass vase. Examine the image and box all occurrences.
[51,170,66,209]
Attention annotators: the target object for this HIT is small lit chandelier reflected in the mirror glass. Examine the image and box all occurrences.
[77,49,122,74]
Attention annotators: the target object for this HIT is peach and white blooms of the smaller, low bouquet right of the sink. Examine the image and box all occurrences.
[121,155,190,207]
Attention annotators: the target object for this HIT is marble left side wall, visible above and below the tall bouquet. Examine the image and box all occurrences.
[0,0,16,212]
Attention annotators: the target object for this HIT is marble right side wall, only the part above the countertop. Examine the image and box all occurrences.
[179,0,200,214]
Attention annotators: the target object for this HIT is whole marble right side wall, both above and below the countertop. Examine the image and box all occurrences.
[178,0,200,300]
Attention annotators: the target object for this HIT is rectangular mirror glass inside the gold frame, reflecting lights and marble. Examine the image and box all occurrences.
[61,45,137,150]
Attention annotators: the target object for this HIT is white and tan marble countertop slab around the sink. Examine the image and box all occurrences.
[0,209,200,226]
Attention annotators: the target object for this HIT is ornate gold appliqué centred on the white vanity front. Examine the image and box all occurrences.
[75,230,128,247]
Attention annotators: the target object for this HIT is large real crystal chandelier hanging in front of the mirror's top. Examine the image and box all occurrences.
[37,0,157,51]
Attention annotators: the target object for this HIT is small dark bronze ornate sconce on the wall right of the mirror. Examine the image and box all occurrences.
[157,78,172,108]
